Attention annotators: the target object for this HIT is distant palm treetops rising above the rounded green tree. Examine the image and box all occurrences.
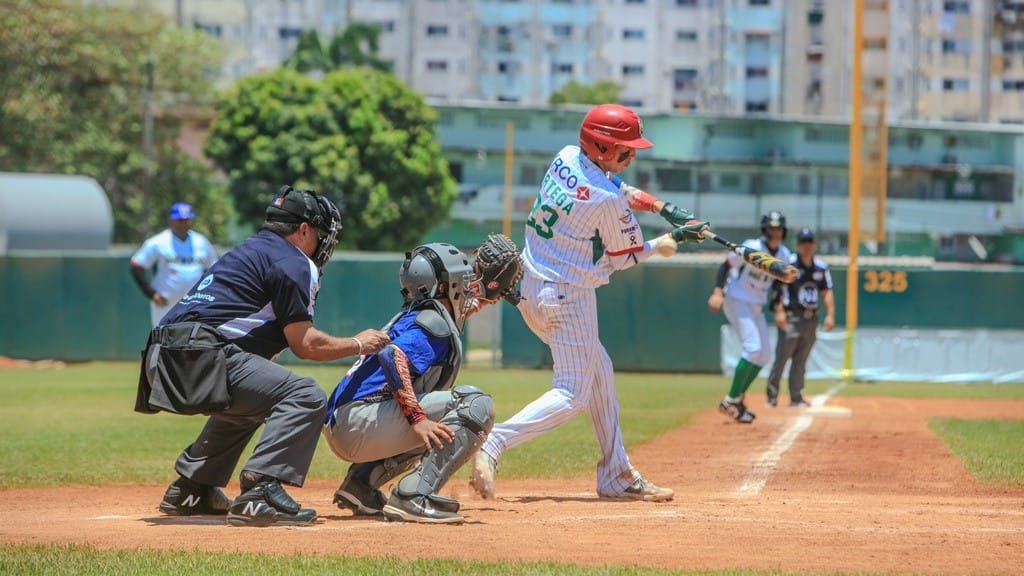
[285,22,388,73]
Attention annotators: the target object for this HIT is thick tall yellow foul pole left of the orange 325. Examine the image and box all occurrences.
[843,0,864,381]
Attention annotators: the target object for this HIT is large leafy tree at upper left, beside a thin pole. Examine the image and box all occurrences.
[0,0,230,242]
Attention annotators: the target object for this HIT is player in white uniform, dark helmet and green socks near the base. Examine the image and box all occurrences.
[708,211,790,424]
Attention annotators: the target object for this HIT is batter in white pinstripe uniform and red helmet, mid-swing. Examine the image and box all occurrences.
[471,105,708,501]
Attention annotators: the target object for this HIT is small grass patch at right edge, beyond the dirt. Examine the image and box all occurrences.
[928,418,1024,486]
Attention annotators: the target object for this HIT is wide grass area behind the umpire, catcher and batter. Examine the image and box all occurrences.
[0,363,726,489]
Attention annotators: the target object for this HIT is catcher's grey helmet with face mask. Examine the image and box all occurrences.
[398,242,476,331]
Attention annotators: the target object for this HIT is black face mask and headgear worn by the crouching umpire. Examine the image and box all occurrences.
[266,186,342,272]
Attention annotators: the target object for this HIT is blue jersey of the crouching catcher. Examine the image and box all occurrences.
[327,311,450,418]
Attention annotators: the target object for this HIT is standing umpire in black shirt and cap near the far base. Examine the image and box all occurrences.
[766,228,836,407]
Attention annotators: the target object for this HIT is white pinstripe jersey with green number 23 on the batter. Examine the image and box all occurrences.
[522,146,654,288]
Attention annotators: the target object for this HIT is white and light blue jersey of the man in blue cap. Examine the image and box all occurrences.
[131,229,217,302]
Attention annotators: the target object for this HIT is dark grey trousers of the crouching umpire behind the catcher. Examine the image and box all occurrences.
[174,344,327,486]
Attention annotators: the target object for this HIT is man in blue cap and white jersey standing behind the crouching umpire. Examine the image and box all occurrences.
[131,202,217,326]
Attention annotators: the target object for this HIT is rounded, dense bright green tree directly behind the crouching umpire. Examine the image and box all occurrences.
[206,68,456,250]
